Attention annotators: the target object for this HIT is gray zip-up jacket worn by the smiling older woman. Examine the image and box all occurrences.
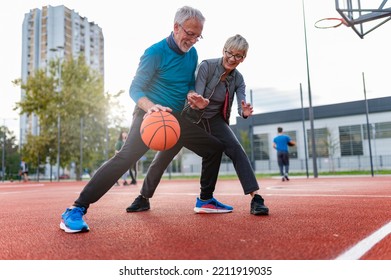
[195,58,246,120]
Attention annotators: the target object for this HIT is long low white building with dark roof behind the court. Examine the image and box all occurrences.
[182,97,391,173]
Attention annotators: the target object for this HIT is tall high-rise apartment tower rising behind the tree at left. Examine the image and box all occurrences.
[20,5,104,145]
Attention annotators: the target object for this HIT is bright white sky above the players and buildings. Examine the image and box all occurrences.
[0,0,391,138]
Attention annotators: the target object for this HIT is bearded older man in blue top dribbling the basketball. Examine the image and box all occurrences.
[60,6,232,233]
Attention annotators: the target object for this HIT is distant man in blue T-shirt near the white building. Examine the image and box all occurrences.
[273,127,296,182]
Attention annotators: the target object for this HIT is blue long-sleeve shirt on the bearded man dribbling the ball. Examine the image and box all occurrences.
[129,39,198,112]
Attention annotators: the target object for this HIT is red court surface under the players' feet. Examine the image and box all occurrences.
[0,176,391,260]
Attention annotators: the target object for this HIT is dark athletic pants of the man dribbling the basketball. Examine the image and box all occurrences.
[74,106,224,210]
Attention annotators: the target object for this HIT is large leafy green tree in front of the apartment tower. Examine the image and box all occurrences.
[14,55,125,179]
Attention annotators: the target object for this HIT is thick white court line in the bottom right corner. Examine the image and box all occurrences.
[336,222,391,260]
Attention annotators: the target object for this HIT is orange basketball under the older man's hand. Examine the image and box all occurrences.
[140,111,181,151]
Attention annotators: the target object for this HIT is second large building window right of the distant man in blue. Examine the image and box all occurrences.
[339,125,364,156]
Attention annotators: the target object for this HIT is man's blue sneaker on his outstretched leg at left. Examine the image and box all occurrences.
[60,207,90,233]
